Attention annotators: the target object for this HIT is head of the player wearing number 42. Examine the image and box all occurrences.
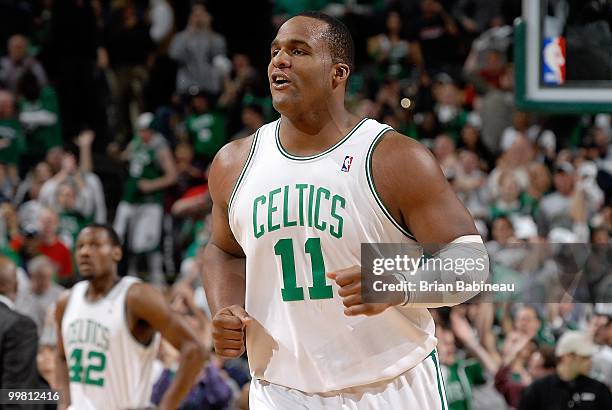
[74,224,123,279]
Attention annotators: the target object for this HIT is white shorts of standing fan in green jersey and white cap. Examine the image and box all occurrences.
[113,201,164,253]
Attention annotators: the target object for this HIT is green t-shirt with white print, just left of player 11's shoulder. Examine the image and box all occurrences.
[185,111,225,161]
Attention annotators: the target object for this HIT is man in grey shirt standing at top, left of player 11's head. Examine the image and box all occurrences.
[168,2,226,95]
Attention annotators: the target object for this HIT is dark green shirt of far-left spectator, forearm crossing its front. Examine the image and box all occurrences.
[19,86,63,155]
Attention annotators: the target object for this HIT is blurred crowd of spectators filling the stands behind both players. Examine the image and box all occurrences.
[0,0,612,410]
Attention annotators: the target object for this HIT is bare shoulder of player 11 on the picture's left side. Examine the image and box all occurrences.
[208,135,254,205]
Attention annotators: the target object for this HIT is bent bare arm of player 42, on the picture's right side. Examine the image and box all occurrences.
[127,283,208,409]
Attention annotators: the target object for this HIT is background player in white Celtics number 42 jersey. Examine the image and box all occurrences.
[55,224,206,410]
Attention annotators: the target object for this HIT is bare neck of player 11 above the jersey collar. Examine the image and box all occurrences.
[279,108,361,156]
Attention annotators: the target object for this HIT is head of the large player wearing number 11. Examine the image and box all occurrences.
[268,12,355,114]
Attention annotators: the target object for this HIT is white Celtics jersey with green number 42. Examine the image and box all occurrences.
[62,277,160,410]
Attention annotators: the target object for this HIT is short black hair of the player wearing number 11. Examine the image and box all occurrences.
[295,11,355,72]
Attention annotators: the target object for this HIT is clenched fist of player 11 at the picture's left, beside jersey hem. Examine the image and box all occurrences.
[212,305,252,357]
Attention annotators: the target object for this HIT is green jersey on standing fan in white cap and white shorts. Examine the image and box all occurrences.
[121,134,169,204]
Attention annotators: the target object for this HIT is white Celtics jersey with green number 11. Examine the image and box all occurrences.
[229,119,436,393]
